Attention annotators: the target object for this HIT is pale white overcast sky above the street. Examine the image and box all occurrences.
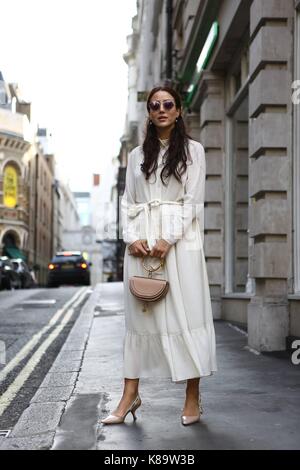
[0,0,136,191]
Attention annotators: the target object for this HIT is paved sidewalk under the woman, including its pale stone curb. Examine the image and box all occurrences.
[0,283,300,451]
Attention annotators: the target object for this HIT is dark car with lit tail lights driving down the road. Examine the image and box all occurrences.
[48,251,91,287]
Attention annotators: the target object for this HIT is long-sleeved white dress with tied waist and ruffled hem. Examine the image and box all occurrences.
[121,140,217,382]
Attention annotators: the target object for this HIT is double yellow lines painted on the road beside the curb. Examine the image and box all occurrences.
[0,288,88,416]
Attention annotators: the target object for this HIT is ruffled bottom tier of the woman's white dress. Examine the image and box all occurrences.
[123,325,218,383]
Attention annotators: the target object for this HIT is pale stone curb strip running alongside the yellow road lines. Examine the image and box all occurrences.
[0,284,100,450]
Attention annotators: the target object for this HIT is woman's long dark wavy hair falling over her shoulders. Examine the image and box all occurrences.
[141,86,191,184]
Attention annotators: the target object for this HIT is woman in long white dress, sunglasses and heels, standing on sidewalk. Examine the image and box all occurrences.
[102,87,217,425]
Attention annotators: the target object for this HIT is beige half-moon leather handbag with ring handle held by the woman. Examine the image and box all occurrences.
[129,256,169,311]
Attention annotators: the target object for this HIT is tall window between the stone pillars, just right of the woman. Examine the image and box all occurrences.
[225,35,251,294]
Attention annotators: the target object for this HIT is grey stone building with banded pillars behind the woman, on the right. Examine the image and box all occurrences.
[123,0,300,351]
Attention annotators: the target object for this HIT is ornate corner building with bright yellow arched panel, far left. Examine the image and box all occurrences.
[0,82,32,259]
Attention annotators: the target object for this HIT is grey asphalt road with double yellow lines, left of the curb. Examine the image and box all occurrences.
[0,287,91,431]
